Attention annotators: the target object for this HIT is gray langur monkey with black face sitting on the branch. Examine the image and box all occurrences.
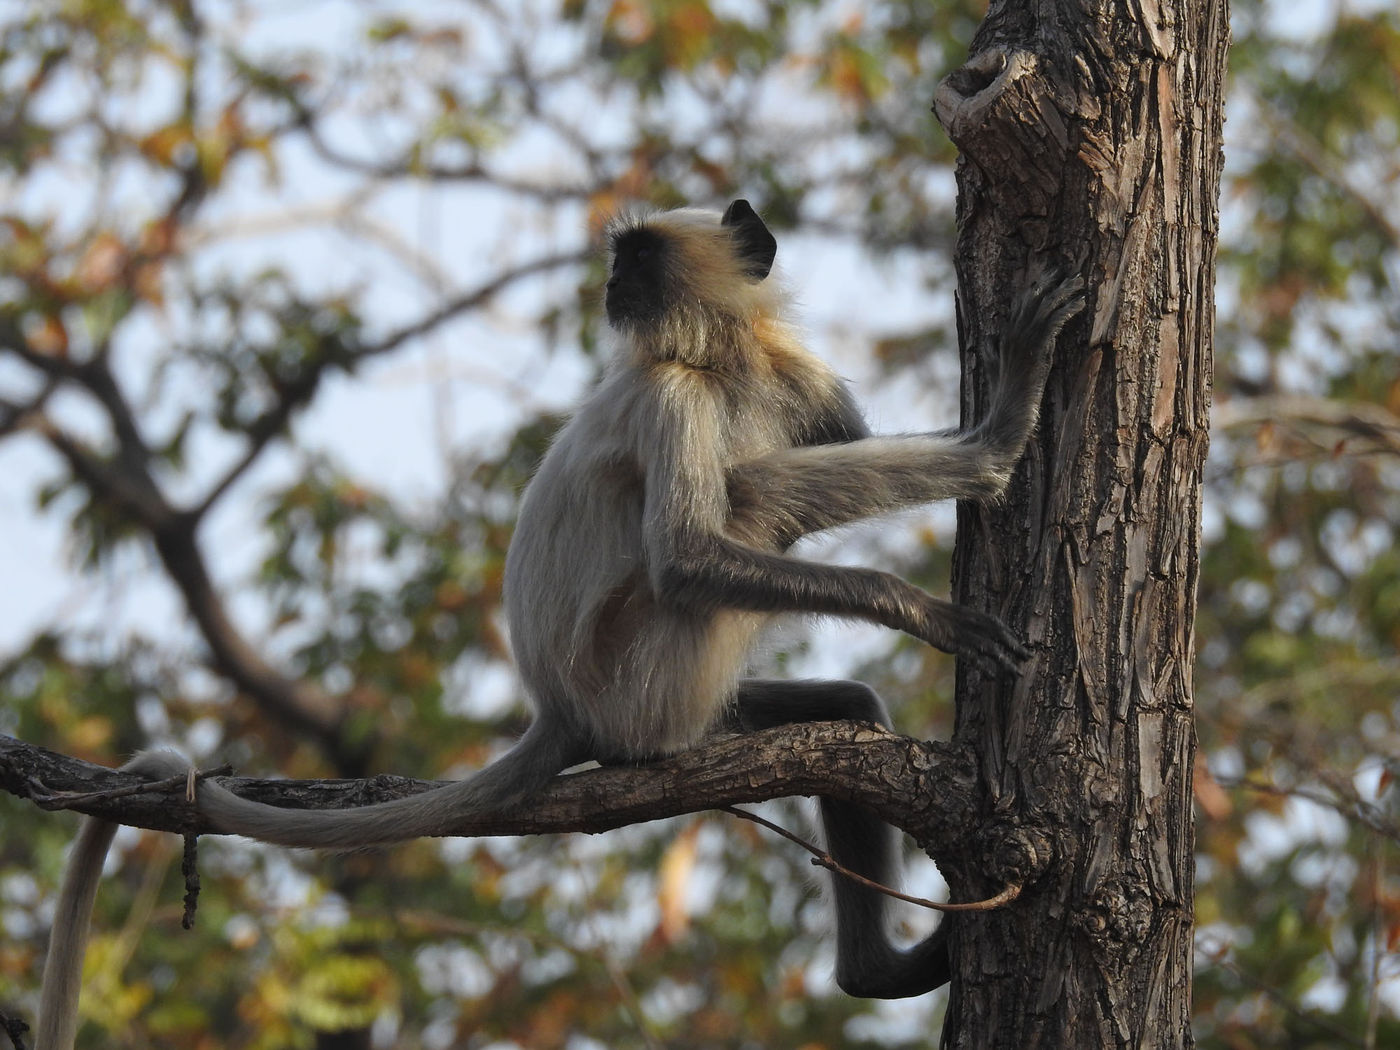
[38,200,1082,1050]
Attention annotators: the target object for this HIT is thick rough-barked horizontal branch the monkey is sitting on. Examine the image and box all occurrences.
[0,722,976,846]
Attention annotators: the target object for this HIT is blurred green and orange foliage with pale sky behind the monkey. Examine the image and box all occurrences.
[0,0,1400,1050]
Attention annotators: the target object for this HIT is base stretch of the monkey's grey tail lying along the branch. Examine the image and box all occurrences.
[199,718,589,850]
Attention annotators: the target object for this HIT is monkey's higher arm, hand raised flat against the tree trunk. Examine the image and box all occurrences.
[725,277,1084,547]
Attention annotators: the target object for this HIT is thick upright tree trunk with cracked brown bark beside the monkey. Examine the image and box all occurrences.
[935,0,1228,1050]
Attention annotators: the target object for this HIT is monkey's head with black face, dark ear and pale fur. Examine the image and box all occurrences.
[605,200,777,337]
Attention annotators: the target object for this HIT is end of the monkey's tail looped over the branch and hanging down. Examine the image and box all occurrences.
[34,750,189,1050]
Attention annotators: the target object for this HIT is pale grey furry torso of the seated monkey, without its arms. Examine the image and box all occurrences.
[505,363,785,759]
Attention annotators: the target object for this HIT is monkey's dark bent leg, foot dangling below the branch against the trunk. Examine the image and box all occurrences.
[735,679,951,1000]
